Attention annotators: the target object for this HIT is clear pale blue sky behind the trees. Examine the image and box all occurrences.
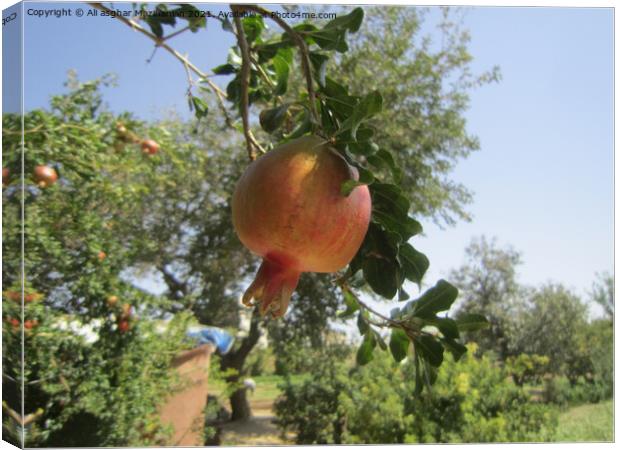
[7,3,613,312]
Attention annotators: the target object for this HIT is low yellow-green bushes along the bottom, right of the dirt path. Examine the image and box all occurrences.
[275,348,557,444]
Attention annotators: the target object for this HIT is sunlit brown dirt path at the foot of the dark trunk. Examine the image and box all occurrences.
[222,401,294,446]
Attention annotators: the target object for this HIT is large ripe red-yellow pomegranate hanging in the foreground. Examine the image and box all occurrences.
[232,136,371,317]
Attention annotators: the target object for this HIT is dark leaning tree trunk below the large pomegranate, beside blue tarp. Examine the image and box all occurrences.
[222,309,261,420]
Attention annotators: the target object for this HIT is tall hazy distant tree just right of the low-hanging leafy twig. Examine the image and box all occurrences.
[450,236,525,359]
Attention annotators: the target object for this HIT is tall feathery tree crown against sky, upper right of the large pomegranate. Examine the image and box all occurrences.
[337,6,500,224]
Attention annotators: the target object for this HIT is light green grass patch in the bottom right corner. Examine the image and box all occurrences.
[554,400,614,442]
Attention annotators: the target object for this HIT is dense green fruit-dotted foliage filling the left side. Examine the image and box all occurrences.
[3,76,208,446]
